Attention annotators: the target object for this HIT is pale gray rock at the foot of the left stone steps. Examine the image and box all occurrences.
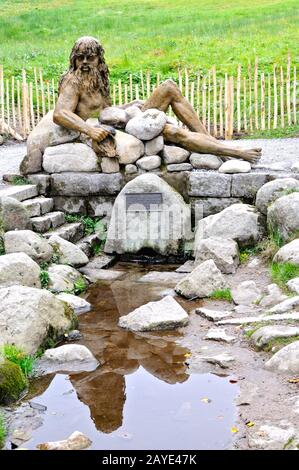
[49,235,88,266]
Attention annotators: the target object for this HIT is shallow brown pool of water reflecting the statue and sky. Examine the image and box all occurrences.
[14,264,238,450]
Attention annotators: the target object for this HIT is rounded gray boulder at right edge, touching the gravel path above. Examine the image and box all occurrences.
[255,178,299,214]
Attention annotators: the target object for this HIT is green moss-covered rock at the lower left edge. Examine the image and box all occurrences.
[0,360,28,405]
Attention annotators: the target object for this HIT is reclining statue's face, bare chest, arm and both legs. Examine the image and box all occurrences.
[53,38,261,163]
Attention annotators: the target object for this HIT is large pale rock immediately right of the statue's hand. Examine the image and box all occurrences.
[115,131,144,165]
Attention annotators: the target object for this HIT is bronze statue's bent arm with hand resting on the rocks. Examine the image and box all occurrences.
[53,85,108,142]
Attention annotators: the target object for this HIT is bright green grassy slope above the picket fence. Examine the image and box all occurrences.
[0,0,299,80]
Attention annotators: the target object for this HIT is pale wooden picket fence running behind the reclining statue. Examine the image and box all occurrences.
[0,56,299,139]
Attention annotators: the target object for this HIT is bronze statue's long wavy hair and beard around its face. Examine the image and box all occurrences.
[58,36,110,106]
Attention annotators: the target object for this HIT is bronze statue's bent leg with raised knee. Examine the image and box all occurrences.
[142,80,211,136]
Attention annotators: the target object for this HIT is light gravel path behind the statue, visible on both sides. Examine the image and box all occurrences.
[0,138,299,181]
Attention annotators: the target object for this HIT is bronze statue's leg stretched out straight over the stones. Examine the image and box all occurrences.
[163,124,261,163]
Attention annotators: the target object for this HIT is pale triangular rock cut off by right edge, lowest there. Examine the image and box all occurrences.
[265,341,299,374]
